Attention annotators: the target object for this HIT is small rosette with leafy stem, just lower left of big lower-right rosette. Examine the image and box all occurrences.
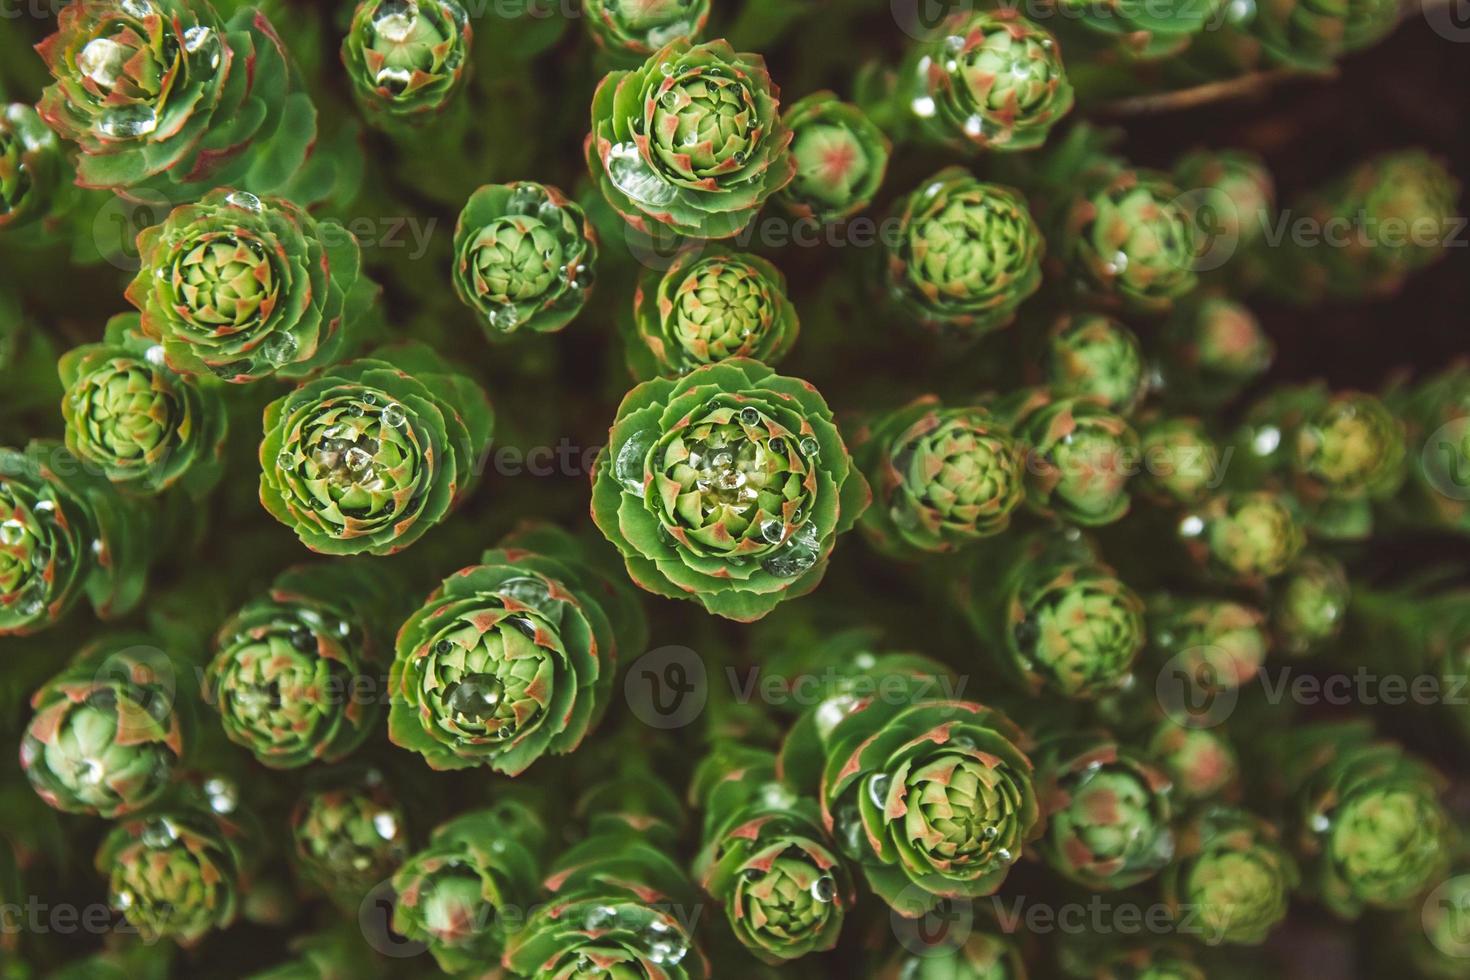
[689,743,857,965]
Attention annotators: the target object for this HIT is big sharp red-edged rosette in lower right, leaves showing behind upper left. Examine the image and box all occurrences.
[781,669,1041,918]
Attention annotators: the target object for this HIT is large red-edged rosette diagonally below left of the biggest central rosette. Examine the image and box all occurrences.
[388,526,645,776]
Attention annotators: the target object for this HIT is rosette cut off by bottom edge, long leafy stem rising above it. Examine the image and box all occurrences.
[503,763,710,980]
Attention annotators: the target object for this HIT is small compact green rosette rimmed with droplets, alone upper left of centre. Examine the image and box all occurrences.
[453,181,597,341]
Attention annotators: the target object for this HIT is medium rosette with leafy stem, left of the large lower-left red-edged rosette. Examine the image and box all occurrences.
[204,558,397,768]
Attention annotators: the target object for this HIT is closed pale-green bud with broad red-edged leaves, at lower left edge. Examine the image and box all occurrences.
[21,633,194,818]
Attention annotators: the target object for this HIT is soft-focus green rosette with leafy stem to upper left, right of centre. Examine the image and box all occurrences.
[953,532,1147,699]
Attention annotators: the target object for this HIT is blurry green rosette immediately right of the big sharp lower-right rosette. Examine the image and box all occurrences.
[1035,732,1175,892]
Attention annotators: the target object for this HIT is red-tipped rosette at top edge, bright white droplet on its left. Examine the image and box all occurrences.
[892,7,1073,153]
